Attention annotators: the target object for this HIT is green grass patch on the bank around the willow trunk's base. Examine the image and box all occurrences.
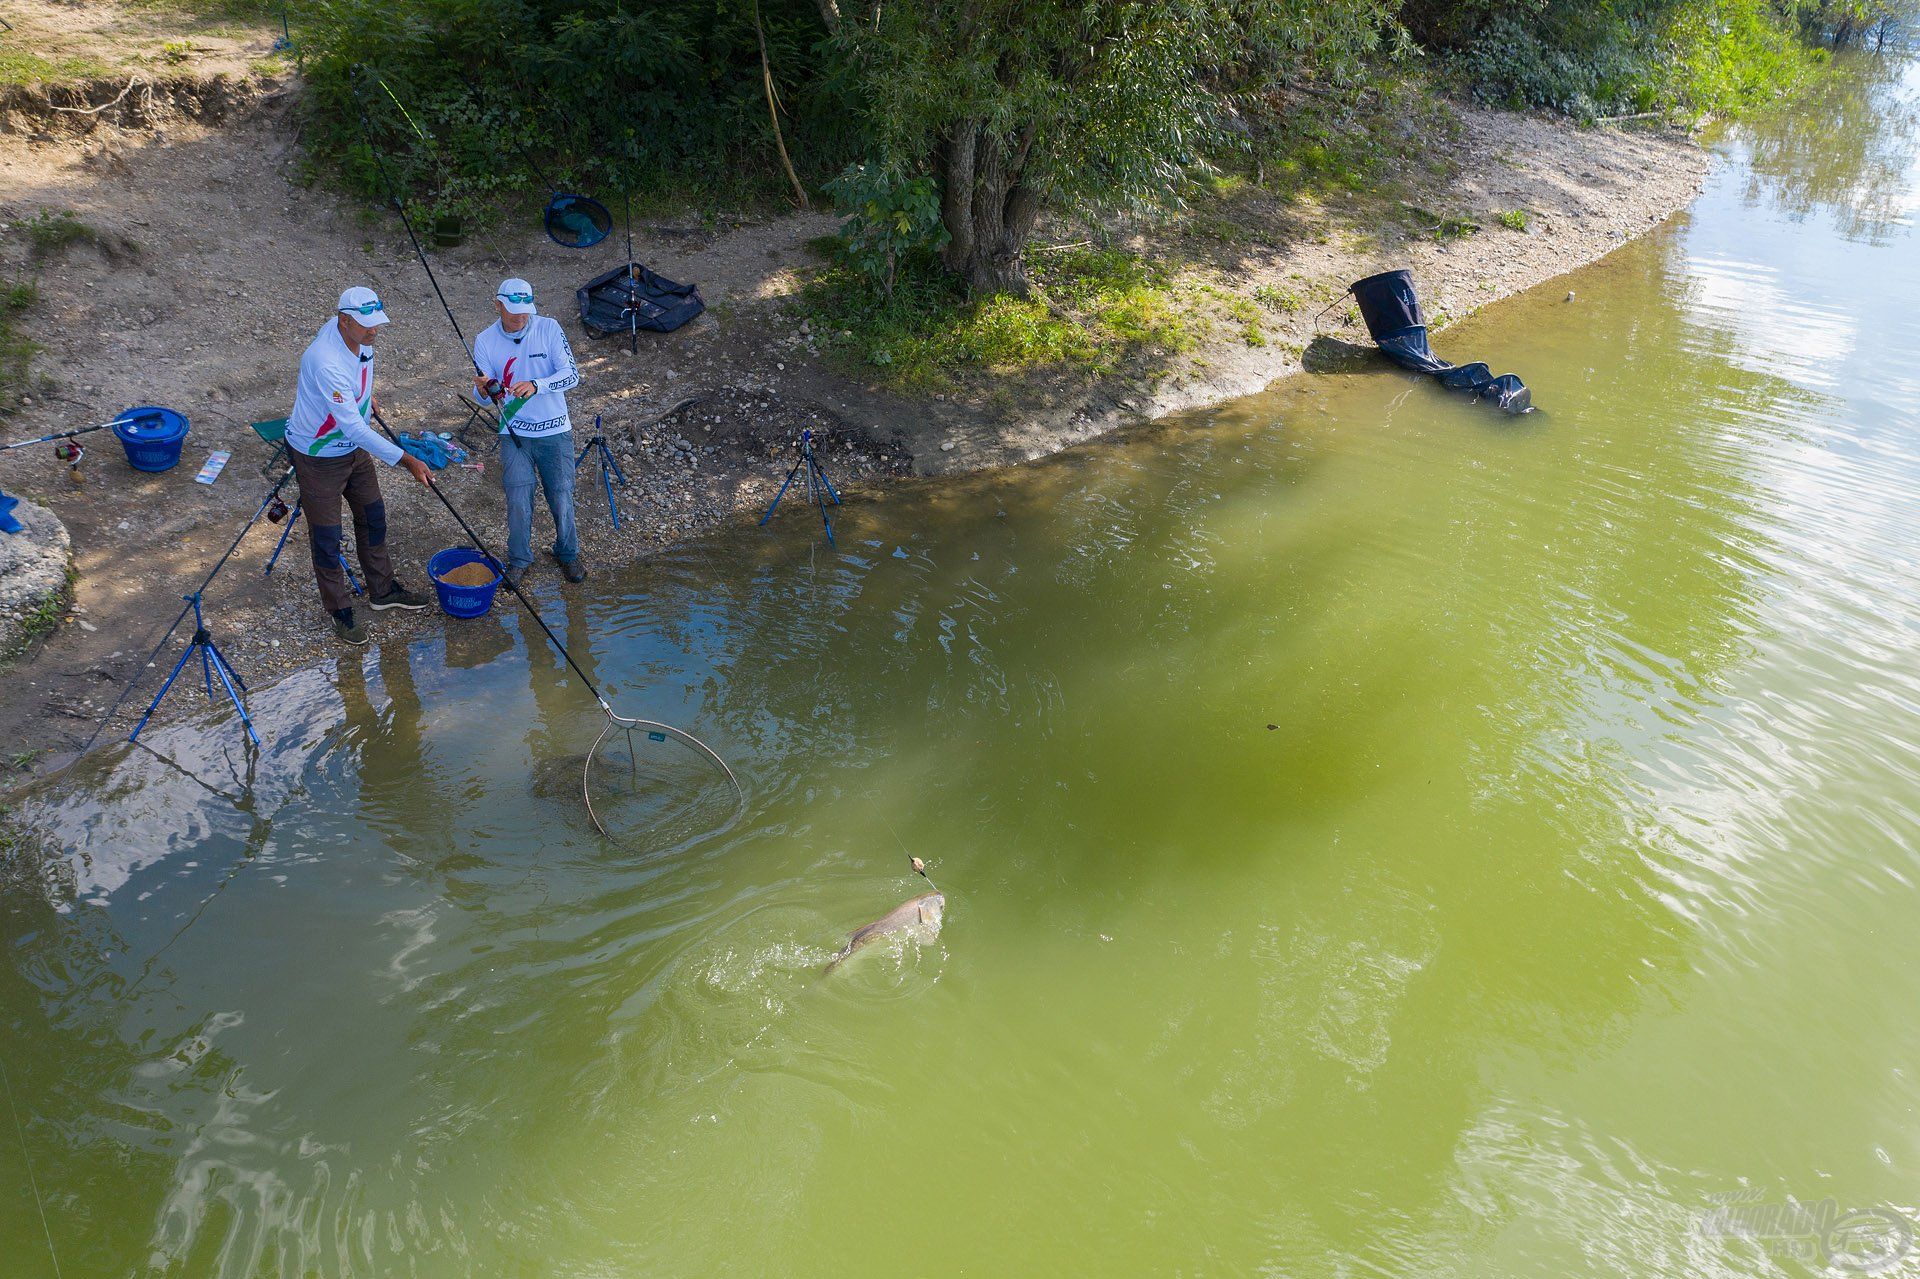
[799,248,1198,394]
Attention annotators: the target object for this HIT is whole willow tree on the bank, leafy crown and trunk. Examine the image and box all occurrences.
[820,0,1392,294]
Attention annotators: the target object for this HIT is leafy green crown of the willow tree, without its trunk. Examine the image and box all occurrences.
[851,0,1392,218]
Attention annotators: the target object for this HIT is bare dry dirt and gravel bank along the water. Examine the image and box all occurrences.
[0,77,1705,780]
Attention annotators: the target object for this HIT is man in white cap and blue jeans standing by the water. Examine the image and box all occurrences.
[474,278,588,586]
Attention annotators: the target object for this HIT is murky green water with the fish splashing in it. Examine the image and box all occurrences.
[0,63,1920,1279]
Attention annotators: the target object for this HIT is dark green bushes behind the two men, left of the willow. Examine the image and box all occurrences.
[292,0,860,225]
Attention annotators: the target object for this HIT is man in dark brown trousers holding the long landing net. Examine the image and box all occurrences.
[286,286,430,643]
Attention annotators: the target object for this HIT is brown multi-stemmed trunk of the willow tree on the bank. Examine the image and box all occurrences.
[935,121,1041,298]
